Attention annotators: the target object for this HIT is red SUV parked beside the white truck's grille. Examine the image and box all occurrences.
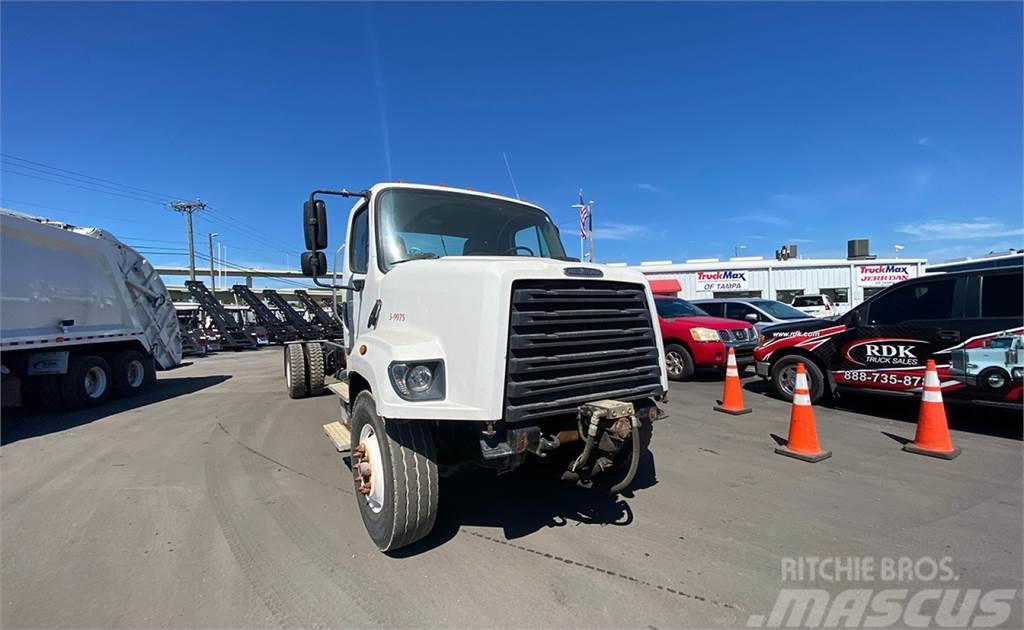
[654,296,758,381]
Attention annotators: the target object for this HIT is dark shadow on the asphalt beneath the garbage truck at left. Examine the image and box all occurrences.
[0,374,231,446]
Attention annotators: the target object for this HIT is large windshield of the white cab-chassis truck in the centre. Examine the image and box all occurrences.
[377,184,565,269]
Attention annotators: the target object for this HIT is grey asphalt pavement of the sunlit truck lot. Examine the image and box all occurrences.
[0,347,1024,628]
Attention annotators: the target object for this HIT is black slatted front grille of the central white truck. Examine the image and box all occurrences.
[505,280,663,422]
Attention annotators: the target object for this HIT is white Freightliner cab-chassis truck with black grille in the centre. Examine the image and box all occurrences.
[285,183,668,551]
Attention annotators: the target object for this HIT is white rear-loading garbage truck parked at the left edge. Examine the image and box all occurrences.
[0,210,181,409]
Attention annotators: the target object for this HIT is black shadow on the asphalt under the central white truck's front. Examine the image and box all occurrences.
[389,452,657,557]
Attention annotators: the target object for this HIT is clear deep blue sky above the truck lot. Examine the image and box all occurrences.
[0,2,1024,278]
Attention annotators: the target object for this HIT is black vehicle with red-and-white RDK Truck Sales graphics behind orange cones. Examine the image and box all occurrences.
[754,267,1024,405]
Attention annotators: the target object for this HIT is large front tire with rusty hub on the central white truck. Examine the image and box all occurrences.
[351,391,437,551]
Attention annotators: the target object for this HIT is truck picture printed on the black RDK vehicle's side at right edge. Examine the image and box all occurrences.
[949,335,1024,393]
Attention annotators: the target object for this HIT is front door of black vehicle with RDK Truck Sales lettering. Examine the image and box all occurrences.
[833,276,966,390]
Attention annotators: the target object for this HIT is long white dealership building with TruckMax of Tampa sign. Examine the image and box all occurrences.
[614,256,927,306]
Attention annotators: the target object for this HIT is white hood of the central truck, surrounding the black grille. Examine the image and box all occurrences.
[349,256,668,420]
